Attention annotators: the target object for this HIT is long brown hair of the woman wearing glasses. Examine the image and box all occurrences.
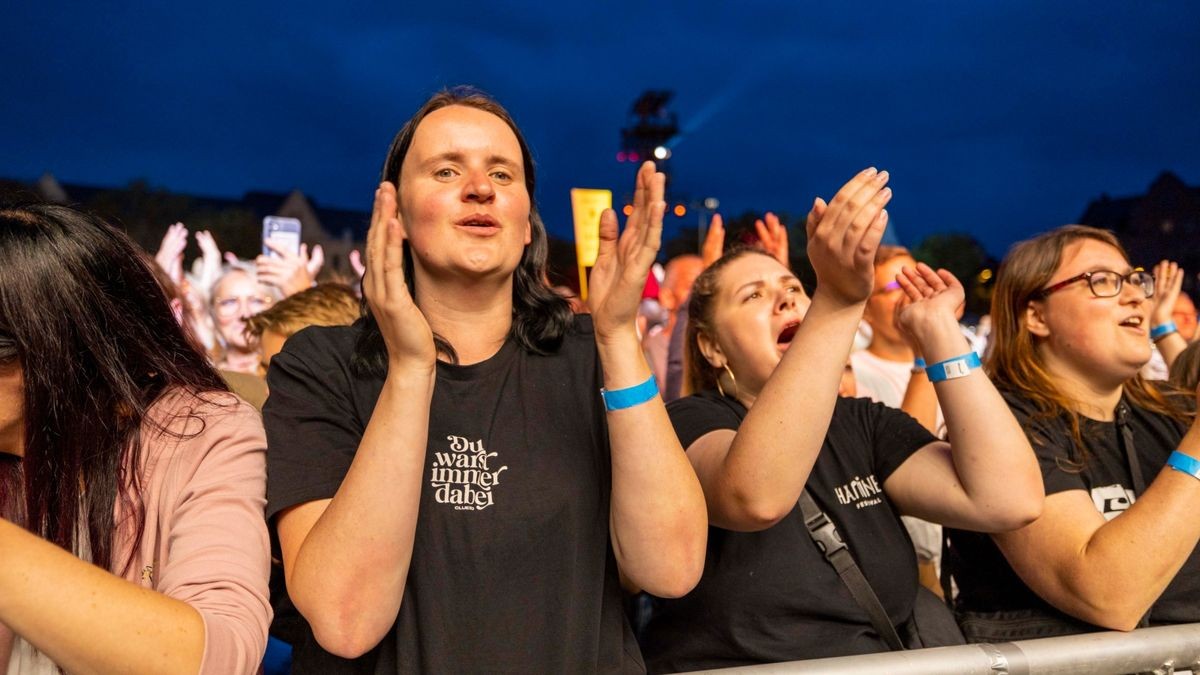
[985,225,1194,468]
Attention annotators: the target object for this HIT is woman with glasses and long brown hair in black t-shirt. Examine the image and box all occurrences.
[948,226,1200,641]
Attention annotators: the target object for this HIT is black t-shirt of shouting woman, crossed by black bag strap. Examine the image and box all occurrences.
[642,392,936,673]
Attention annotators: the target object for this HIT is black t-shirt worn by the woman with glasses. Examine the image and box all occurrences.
[947,392,1200,631]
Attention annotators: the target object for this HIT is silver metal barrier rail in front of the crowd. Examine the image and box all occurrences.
[704,623,1200,675]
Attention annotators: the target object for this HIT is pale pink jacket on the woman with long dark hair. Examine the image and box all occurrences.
[0,392,271,675]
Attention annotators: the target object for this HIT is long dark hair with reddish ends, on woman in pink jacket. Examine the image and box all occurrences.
[0,203,227,573]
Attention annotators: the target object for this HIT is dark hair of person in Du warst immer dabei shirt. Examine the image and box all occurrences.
[350,86,572,376]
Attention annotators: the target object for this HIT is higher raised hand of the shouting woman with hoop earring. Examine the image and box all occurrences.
[806,167,892,305]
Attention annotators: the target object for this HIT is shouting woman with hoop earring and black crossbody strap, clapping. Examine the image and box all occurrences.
[643,169,1042,671]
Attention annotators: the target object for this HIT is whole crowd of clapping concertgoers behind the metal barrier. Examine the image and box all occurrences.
[0,89,1200,675]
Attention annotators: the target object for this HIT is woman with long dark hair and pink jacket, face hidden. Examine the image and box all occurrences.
[0,204,270,675]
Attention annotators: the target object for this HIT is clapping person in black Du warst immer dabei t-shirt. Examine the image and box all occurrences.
[264,90,707,674]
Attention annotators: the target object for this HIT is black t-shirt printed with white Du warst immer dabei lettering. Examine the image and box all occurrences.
[264,317,643,675]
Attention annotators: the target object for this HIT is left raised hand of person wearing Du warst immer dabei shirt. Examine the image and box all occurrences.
[362,181,438,372]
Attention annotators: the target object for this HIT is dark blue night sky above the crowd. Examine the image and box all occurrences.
[0,0,1200,255]
